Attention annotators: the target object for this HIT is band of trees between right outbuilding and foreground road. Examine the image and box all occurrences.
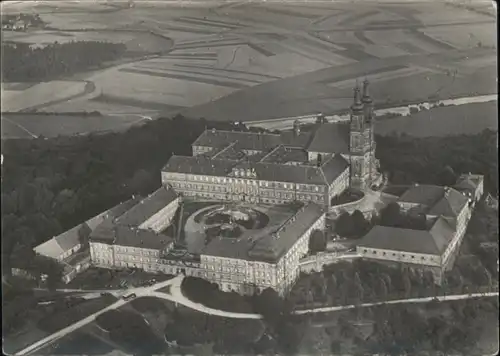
[288,260,495,308]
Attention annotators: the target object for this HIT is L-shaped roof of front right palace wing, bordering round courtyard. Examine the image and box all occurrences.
[203,203,324,262]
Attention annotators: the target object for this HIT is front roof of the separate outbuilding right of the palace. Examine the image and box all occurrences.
[358,218,454,255]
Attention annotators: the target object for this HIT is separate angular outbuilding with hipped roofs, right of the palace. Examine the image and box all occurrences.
[357,178,482,283]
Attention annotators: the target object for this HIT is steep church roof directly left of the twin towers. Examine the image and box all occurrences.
[307,123,350,154]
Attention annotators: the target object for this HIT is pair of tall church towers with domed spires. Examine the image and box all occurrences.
[349,84,373,189]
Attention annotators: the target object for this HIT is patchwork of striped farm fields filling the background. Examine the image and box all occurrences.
[0,1,497,138]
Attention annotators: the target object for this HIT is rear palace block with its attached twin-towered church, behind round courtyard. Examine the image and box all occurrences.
[162,80,379,207]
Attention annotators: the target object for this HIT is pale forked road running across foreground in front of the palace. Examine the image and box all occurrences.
[16,275,498,355]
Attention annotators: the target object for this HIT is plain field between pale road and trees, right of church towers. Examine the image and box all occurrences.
[375,101,498,137]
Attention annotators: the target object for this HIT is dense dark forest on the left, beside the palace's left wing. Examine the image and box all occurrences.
[1,116,238,274]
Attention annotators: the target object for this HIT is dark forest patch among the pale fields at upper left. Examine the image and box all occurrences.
[2,41,127,82]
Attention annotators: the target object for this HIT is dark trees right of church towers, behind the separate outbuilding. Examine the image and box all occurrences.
[376,130,498,195]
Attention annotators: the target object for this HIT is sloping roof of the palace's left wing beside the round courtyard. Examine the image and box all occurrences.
[116,186,177,226]
